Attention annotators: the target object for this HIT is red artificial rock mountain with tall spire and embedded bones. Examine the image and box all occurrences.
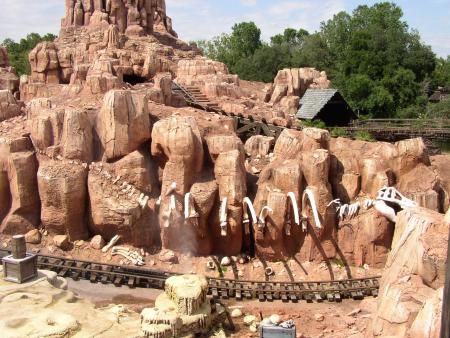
[0,0,450,335]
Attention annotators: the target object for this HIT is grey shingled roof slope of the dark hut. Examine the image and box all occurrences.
[297,89,338,120]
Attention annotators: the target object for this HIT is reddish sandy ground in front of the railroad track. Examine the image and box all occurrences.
[68,279,376,338]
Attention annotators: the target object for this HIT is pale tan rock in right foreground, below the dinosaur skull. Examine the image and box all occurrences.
[373,208,450,337]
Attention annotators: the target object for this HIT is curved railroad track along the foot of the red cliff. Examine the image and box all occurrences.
[0,250,380,302]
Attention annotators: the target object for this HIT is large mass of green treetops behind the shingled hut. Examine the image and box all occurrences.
[199,2,450,118]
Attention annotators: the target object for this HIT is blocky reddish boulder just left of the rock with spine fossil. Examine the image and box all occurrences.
[37,161,89,242]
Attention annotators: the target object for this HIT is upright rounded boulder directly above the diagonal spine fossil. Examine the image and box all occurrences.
[96,90,151,159]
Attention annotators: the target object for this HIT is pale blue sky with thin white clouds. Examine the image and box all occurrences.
[0,0,450,57]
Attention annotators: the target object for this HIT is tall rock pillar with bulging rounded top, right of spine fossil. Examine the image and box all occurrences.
[151,116,207,252]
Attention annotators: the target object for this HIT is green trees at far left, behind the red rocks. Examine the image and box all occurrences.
[1,33,56,76]
